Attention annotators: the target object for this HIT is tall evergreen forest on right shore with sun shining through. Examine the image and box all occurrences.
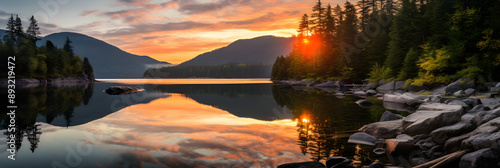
[271,0,500,86]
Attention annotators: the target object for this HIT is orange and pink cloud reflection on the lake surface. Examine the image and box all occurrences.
[79,94,307,167]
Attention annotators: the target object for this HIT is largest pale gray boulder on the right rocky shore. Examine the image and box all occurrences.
[402,103,463,136]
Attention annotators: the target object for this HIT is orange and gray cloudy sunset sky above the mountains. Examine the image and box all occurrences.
[0,0,345,64]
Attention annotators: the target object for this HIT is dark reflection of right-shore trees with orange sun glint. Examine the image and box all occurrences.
[273,86,382,161]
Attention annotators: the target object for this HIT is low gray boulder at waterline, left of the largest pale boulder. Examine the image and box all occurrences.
[359,120,403,139]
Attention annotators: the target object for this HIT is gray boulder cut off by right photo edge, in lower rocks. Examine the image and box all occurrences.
[461,117,500,150]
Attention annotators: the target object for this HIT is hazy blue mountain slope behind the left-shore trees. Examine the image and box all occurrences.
[0,30,170,79]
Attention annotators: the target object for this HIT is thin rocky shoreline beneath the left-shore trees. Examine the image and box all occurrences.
[0,75,98,88]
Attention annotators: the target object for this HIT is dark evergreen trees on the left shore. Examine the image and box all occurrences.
[0,15,94,79]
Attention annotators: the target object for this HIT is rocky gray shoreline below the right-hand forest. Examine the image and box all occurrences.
[273,78,500,168]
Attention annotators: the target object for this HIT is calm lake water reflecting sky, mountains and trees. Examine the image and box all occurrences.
[0,79,385,168]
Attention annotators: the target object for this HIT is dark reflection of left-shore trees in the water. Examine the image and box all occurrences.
[0,83,94,152]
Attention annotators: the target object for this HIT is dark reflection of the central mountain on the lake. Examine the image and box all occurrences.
[144,84,291,120]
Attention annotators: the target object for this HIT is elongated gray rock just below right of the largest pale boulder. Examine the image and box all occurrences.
[430,120,476,144]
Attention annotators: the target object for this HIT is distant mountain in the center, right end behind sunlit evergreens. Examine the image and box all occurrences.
[180,36,294,66]
